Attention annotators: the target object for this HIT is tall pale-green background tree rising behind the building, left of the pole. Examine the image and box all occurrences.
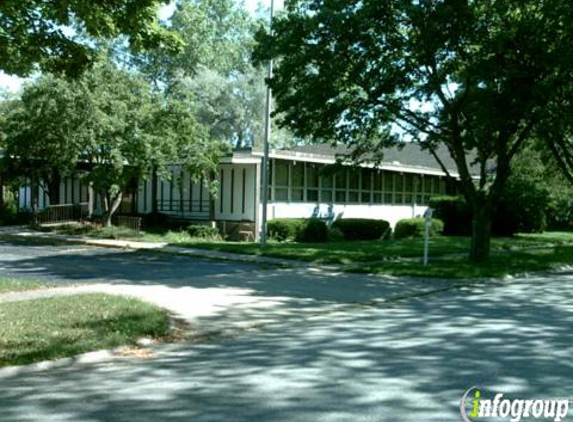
[132,0,292,147]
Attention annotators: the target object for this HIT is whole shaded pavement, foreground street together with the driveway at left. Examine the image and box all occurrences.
[0,239,573,422]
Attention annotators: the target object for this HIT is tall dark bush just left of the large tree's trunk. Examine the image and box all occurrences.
[429,196,472,236]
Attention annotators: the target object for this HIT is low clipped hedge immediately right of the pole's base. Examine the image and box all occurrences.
[267,218,328,243]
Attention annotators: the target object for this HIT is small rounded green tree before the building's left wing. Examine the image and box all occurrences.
[2,62,223,225]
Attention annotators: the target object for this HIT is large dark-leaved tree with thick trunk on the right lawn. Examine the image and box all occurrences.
[255,0,573,262]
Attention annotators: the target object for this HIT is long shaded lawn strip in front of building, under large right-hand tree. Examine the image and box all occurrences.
[35,223,573,278]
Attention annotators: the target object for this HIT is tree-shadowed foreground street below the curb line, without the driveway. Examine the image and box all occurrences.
[0,274,573,422]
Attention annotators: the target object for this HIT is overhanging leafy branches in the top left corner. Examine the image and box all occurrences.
[0,0,181,76]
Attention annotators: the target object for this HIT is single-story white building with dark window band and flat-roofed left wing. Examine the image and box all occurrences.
[19,143,464,237]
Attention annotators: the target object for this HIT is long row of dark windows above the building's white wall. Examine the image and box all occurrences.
[269,160,447,205]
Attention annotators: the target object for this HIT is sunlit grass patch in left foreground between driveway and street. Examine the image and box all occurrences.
[0,294,169,367]
